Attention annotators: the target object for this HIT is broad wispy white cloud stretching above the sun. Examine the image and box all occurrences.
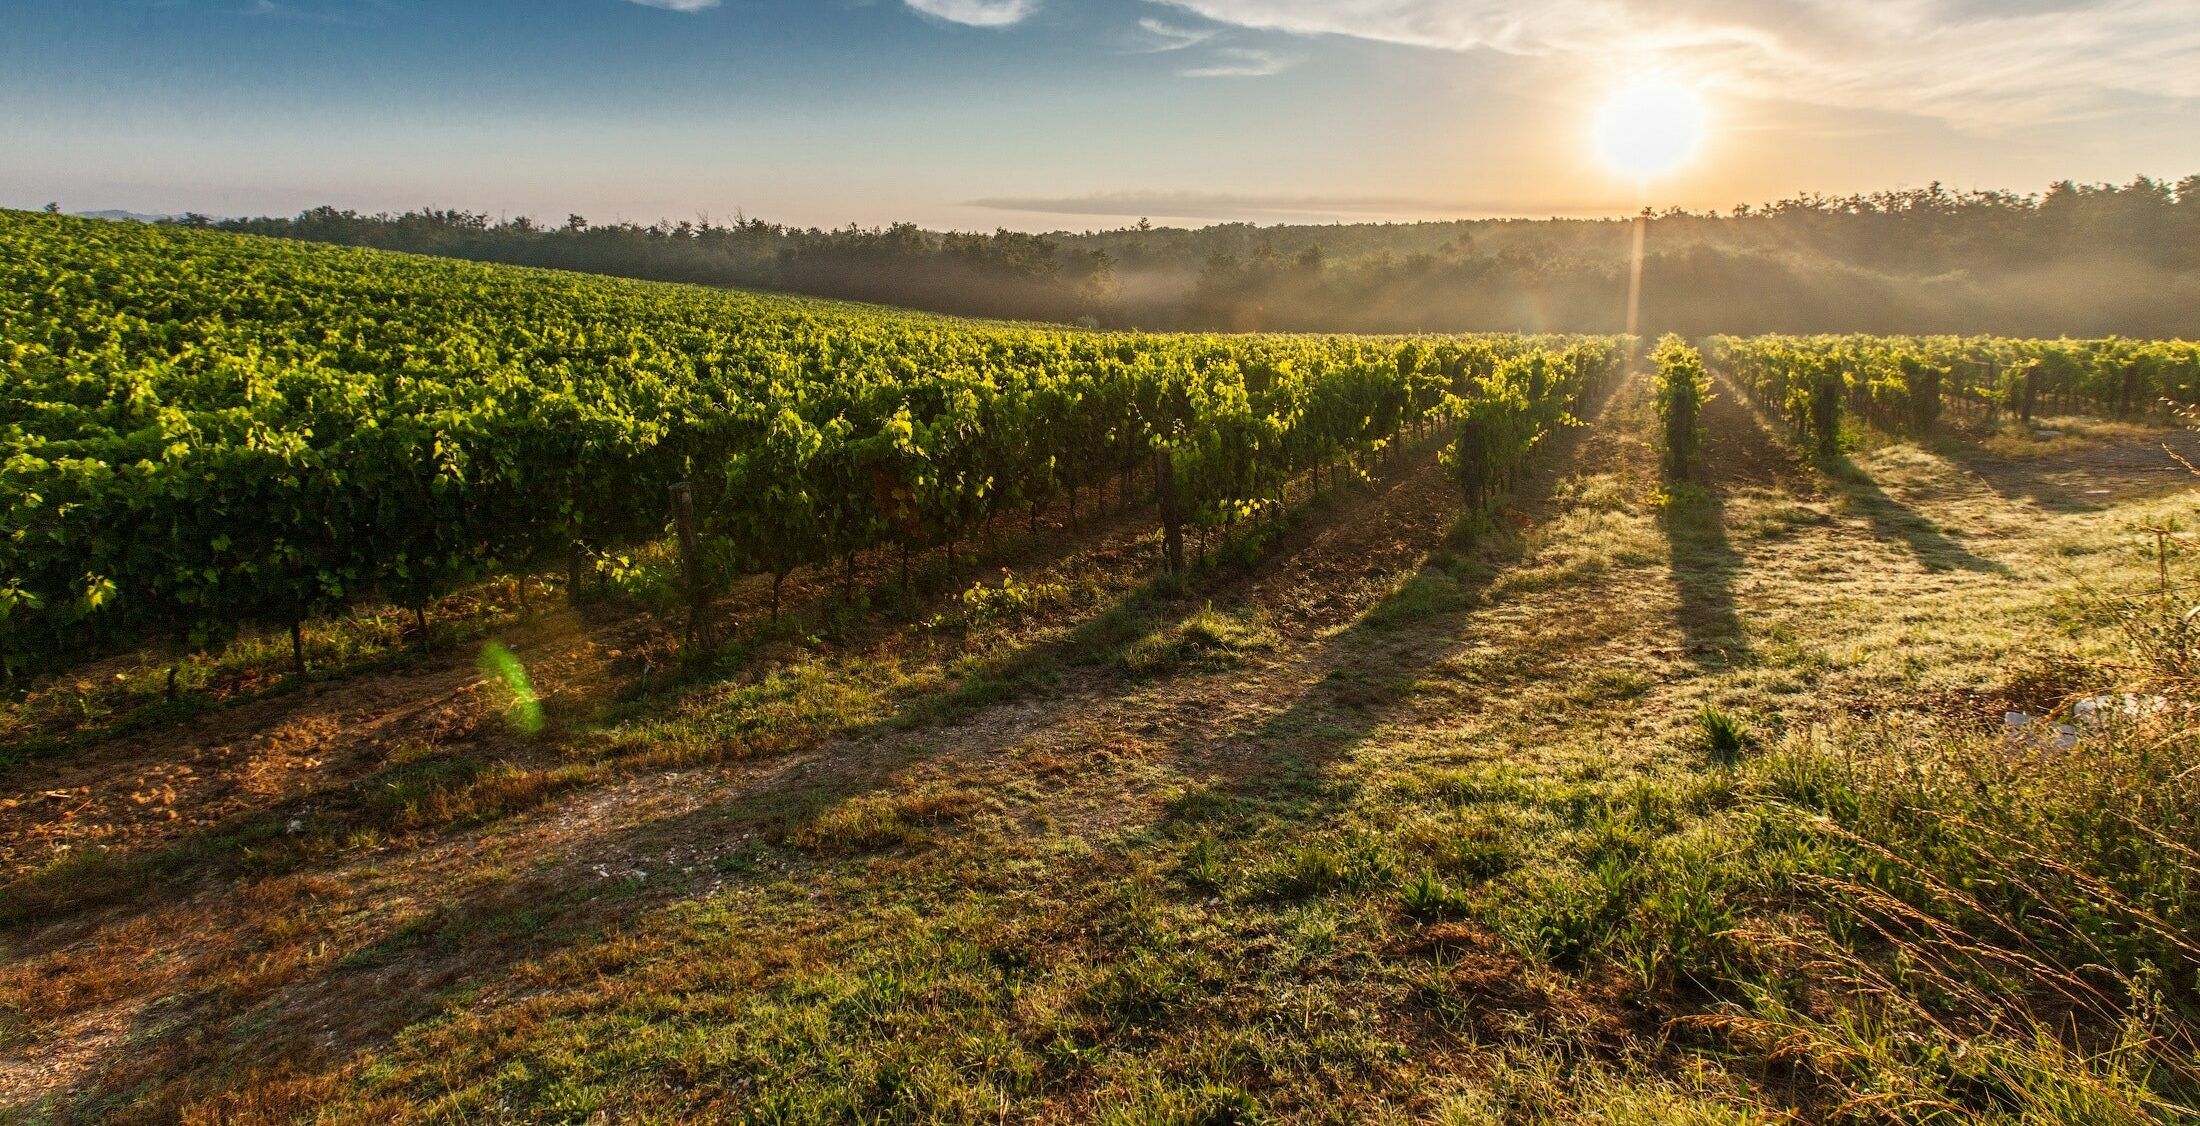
[1155,0,2200,128]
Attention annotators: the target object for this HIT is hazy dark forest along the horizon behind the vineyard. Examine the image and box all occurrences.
[193,176,2200,336]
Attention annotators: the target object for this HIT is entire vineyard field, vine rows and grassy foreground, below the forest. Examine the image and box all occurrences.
[0,216,2200,1124]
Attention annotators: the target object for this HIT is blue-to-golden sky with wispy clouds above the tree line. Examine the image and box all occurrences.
[0,0,2200,231]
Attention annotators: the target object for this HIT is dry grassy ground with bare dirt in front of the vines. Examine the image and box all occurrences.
[0,376,2200,1122]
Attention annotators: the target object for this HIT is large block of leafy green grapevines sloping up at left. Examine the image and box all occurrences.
[0,213,1621,675]
